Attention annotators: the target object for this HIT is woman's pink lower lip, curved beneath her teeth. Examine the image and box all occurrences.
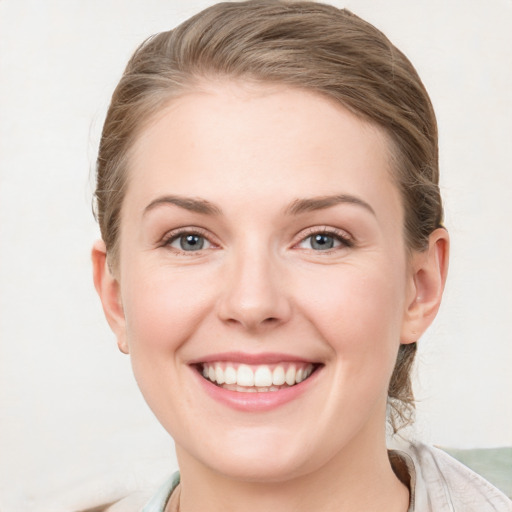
[192,368,321,412]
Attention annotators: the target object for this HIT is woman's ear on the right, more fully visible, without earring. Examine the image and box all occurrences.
[400,228,450,344]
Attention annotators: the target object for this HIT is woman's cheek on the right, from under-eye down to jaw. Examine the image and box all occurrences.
[294,265,405,426]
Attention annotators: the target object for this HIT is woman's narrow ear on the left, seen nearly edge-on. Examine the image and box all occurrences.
[91,240,128,354]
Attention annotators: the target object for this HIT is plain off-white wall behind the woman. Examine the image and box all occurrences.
[0,0,512,512]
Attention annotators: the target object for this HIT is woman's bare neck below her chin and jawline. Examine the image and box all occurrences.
[177,424,409,512]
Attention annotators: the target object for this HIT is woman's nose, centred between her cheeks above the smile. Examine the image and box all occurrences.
[218,245,292,331]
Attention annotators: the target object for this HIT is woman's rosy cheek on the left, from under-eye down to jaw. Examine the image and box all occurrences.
[118,265,218,426]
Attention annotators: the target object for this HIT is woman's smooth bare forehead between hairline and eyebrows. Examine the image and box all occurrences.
[128,81,400,220]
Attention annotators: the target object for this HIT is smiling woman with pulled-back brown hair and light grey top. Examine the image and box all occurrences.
[93,1,510,512]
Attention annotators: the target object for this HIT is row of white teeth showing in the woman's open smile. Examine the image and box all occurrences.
[202,362,313,393]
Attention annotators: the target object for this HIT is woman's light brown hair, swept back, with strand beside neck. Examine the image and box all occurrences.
[95,0,443,430]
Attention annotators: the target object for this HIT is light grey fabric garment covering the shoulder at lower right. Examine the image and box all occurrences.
[404,443,512,512]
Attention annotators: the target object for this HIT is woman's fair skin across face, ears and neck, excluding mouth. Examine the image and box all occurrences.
[93,82,448,512]
